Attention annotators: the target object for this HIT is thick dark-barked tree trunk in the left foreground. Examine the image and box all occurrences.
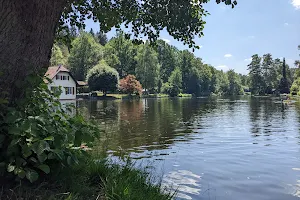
[0,0,67,101]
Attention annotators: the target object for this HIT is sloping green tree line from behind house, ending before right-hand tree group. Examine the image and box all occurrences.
[51,29,247,96]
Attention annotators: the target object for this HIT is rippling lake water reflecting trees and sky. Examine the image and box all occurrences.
[77,97,300,200]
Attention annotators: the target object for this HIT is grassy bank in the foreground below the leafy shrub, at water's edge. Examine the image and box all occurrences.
[0,159,174,200]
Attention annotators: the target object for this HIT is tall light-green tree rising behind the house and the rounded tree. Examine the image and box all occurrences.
[68,31,103,80]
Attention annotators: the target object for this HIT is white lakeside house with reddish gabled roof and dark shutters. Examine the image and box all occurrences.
[45,65,77,100]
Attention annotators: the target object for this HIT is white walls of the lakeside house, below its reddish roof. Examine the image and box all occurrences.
[48,72,76,100]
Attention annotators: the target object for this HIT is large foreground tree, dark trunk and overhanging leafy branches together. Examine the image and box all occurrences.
[0,0,237,100]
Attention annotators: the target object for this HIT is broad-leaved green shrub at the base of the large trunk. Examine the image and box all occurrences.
[0,76,98,182]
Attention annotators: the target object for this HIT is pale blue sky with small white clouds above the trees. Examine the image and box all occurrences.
[86,0,300,74]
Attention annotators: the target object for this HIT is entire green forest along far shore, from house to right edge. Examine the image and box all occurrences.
[50,29,300,96]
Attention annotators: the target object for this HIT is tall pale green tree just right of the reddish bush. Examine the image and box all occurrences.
[135,42,160,91]
